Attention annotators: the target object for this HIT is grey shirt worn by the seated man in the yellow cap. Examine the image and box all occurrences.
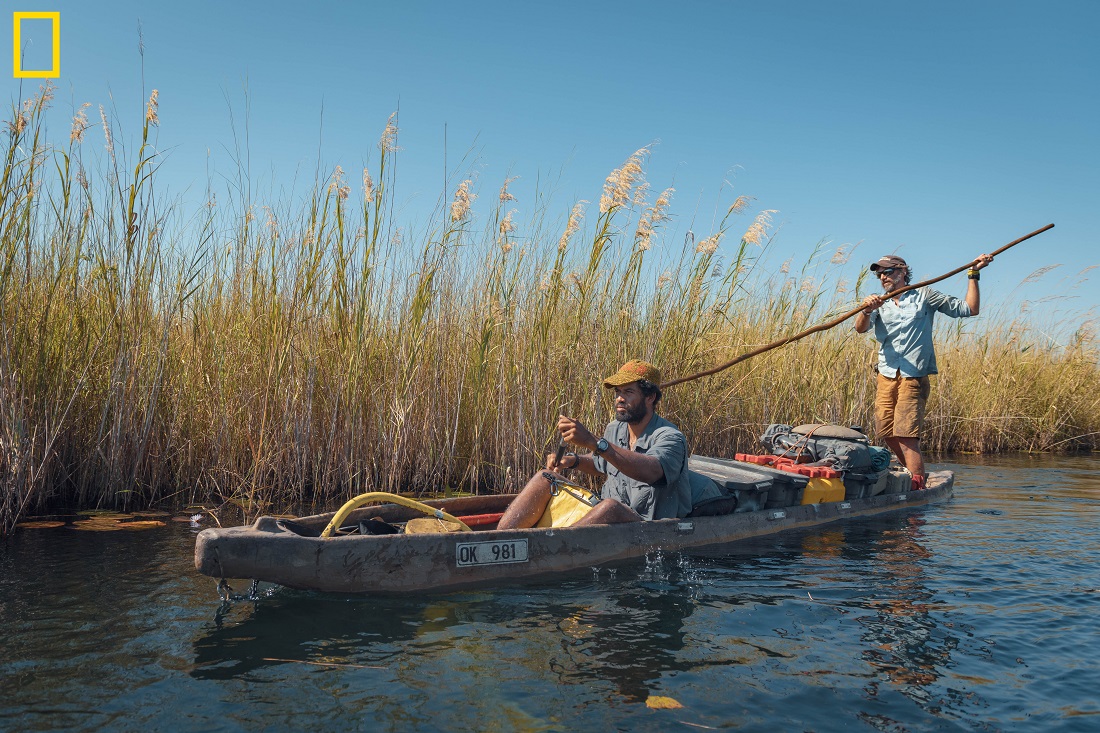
[592,415,692,519]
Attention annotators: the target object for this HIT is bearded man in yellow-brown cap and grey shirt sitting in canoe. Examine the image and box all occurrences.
[497,359,692,529]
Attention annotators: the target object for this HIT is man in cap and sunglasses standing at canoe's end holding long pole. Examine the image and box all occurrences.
[856,254,993,490]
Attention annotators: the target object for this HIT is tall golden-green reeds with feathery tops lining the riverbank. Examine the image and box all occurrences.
[0,88,1100,534]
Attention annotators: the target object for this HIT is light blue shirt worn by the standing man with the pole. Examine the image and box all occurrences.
[869,287,972,379]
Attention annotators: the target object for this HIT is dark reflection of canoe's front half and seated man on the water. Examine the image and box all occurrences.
[190,556,694,701]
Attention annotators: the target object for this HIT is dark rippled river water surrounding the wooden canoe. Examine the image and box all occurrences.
[0,458,1100,731]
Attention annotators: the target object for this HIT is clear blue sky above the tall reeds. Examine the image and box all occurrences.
[10,0,1100,325]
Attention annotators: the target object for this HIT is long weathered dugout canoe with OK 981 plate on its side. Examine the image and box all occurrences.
[195,457,955,593]
